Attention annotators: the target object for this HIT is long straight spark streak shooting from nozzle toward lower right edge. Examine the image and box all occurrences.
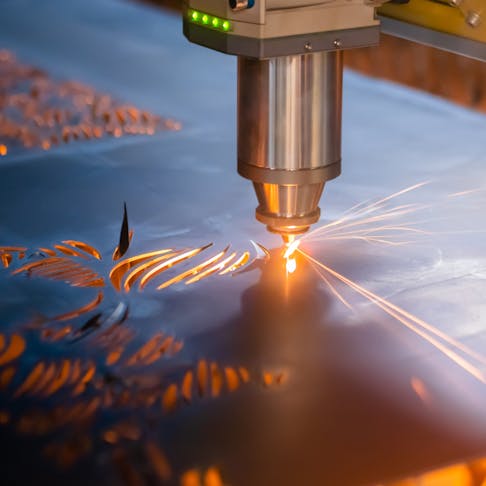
[298,249,486,383]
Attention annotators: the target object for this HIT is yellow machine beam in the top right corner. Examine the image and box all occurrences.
[378,0,486,43]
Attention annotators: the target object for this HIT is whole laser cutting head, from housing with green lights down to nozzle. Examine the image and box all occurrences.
[184,0,379,242]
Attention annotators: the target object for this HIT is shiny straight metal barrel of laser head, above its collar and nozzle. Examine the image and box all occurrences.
[238,51,343,171]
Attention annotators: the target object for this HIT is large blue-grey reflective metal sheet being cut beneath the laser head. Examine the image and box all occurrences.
[0,0,486,486]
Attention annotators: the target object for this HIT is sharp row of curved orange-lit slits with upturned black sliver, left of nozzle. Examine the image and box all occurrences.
[0,232,269,350]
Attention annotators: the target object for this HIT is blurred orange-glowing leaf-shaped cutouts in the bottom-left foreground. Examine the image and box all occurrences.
[0,326,285,485]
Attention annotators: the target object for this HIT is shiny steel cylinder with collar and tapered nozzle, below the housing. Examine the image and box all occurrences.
[238,51,342,237]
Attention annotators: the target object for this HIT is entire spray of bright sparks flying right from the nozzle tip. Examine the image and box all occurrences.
[283,182,486,383]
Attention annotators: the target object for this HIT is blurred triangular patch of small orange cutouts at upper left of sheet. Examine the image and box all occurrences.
[0,50,181,157]
